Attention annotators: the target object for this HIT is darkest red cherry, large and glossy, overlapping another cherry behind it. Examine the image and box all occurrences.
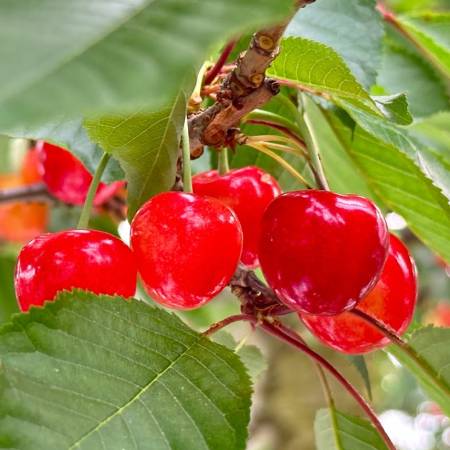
[259,190,389,315]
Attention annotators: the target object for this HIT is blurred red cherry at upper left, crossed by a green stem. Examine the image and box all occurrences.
[36,141,124,206]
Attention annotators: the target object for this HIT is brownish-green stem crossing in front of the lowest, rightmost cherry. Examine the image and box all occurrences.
[349,308,450,395]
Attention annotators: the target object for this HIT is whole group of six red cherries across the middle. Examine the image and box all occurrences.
[15,143,417,353]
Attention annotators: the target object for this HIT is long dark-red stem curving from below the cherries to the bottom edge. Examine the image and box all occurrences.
[260,321,396,450]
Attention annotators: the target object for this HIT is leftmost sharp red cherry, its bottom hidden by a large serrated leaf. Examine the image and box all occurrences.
[15,230,137,311]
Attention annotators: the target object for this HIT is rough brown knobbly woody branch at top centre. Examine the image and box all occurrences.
[189,0,314,158]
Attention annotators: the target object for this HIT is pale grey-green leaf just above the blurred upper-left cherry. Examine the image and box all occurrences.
[2,118,124,182]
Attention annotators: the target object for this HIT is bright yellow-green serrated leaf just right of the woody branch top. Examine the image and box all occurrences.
[268,37,375,108]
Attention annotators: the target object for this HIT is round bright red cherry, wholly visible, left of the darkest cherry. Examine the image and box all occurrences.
[131,192,242,309]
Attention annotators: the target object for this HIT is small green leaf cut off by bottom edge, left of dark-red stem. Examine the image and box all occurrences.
[314,409,387,450]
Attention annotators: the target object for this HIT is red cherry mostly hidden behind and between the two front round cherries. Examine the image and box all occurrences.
[192,167,281,268]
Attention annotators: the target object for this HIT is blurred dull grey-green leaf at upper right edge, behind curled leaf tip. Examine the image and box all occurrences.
[377,42,450,117]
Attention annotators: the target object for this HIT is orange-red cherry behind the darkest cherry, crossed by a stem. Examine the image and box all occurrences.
[301,235,417,354]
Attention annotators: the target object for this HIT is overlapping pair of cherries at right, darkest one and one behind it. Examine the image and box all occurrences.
[260,191,417,353]
